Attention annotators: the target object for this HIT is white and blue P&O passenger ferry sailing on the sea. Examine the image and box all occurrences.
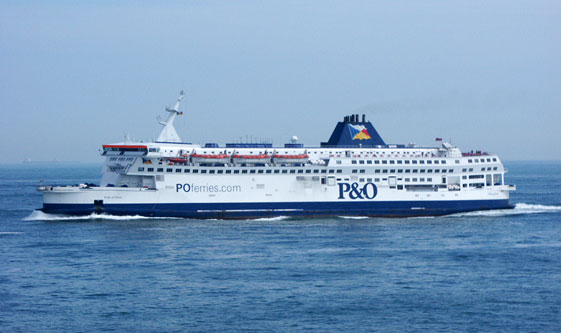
[38,93,516,219]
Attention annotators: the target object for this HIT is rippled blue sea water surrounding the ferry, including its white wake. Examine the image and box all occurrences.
[0,162,561,332]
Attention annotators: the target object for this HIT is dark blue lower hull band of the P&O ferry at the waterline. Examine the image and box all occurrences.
[43,200,513,219]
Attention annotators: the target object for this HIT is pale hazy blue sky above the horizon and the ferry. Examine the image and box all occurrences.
[0,0,561,163]
